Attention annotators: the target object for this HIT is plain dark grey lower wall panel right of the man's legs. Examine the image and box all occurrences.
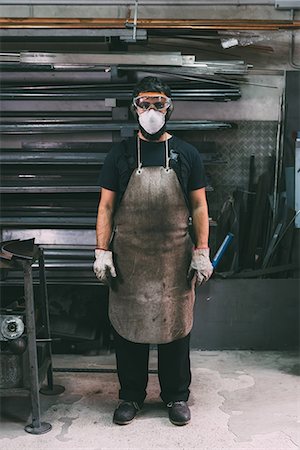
[191,279,300,350]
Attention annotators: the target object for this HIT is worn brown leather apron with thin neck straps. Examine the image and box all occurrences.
[109,138,195,344]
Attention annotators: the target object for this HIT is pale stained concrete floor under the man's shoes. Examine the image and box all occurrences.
[0,351,300,450]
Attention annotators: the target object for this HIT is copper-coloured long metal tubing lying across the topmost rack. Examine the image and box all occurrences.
[0,17,300,30]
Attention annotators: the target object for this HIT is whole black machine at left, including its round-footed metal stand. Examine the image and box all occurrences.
[0,239,64,434]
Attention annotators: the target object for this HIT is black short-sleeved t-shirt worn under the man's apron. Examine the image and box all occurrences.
[100,136,207,194]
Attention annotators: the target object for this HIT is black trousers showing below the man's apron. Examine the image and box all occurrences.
[114,330,191,404]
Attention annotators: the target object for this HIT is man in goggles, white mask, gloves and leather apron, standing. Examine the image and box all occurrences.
[94,77,213,425]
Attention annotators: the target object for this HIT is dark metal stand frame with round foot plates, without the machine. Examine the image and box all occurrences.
[0,241,65,434]
